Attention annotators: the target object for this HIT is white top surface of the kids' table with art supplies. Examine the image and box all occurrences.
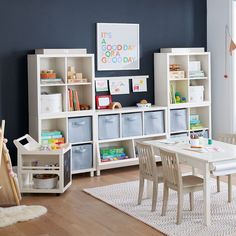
[145,140,236,163]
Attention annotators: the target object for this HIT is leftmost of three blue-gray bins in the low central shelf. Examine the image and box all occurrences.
[98,114,120,140]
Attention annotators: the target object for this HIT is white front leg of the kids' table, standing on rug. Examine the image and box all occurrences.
[203,163,211,226]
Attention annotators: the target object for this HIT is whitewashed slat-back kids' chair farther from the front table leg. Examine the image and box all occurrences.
[136,142,163,211]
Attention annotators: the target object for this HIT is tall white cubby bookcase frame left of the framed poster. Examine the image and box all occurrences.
[28,54,96,176]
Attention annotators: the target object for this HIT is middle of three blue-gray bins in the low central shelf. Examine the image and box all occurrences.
[122,112,142,137]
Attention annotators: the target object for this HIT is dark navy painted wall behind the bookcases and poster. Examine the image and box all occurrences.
[0,0,206,162]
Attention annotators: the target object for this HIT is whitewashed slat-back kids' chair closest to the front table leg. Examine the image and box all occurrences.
[160,149,203,224]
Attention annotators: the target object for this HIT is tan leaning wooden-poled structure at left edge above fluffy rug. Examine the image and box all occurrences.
[0,121,21,206]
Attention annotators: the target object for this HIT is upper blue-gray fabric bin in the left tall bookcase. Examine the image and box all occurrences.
[68,116,92,143]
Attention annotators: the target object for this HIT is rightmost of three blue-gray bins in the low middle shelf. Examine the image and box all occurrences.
[144,111,165,135]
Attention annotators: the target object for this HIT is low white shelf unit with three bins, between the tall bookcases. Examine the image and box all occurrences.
[96,106,167,175]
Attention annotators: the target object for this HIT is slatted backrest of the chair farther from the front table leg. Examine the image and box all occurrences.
[136,142,157,179]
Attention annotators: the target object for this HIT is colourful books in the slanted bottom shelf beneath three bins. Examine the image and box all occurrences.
[100,147,129,162]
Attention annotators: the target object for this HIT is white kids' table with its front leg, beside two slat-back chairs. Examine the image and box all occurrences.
[145,140,236,225]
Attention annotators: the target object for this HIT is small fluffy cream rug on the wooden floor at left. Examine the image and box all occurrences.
[0,205,47,227]
